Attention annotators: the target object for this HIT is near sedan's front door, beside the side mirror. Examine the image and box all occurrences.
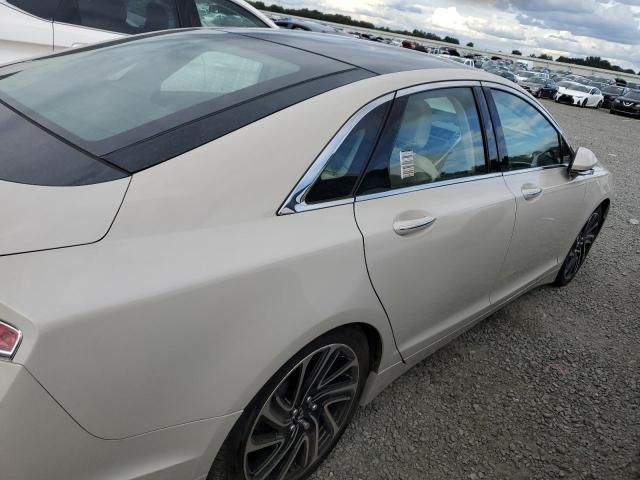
[485,86,586,303]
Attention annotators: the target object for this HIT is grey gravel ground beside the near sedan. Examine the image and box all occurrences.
[313,101,640,480]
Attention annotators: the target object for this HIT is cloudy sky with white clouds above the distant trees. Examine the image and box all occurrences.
[276,0,640,71]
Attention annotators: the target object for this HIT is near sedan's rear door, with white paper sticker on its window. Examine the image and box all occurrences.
[355,82,515,363]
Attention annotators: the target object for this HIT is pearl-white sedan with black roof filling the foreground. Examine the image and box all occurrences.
[0,29,611,480]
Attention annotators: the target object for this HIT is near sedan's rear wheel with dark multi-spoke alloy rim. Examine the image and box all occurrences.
[208,328,369,480]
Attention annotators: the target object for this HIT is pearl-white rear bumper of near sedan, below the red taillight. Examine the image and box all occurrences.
[0,361,240,480]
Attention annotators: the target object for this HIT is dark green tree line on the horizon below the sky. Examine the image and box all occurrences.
[249,1,640,75]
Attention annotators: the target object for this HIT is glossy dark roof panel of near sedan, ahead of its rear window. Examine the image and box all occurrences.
[228,29,464,75]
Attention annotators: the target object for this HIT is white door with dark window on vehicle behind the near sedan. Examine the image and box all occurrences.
[53,0,180,51]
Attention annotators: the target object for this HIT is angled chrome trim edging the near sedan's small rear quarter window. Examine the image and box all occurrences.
[277,93,395,215]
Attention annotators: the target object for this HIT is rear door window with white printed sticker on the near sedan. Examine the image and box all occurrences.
[359,88,487,195]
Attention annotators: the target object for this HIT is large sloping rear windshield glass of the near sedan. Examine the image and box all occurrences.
[0,30,351,155]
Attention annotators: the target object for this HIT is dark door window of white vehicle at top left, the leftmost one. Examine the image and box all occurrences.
[55,0,180,34]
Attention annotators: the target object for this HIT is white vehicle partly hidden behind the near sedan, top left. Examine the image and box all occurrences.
[0,0,277,64]
